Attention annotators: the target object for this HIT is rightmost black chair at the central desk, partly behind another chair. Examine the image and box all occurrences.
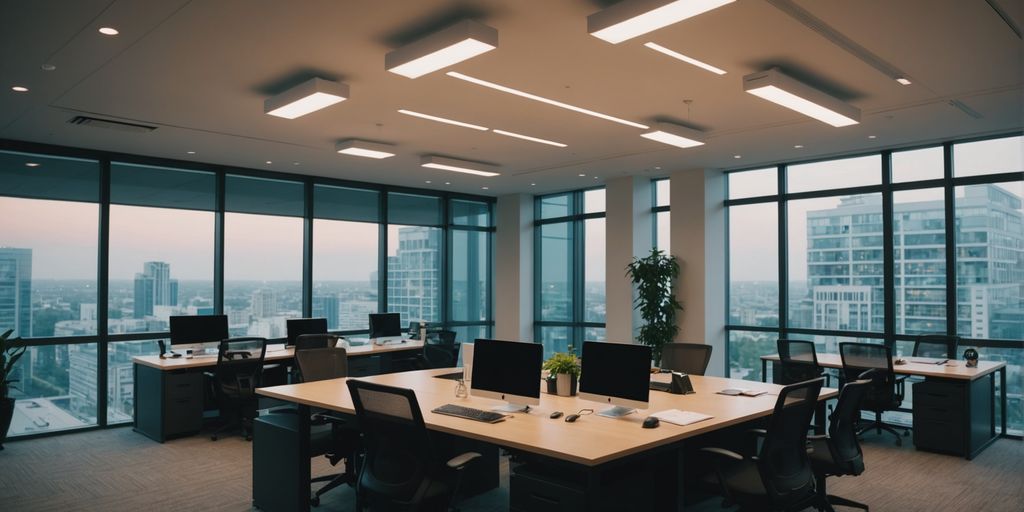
[807,370,877,511]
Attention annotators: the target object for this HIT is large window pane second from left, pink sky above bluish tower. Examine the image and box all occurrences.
[108,205,214,334]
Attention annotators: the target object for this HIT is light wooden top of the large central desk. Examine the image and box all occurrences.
[257,369,837,466]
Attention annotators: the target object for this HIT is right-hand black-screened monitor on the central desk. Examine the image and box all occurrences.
[580,341,651,418]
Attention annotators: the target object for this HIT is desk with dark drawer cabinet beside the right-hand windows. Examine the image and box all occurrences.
[761,353,1007,460]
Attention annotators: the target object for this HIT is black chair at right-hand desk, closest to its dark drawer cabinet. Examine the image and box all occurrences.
[839,343,910,446]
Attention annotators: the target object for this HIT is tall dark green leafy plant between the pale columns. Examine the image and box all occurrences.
[626,248,683,366]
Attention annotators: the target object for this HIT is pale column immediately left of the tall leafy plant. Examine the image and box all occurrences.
[604,176,653,343]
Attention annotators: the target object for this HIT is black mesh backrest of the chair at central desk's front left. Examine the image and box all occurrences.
[347,379,436,503]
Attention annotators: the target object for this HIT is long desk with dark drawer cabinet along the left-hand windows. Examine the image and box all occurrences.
[132,340,423,442]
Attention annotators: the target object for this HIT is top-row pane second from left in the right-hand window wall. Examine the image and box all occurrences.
[786,155,882,193]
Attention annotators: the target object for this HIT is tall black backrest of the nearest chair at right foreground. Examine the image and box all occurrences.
[757,378,824,509]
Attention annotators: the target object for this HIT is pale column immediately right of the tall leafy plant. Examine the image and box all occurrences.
[669,169,728,376]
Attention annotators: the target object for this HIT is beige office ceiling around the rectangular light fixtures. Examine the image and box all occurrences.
[0,0,1024,196]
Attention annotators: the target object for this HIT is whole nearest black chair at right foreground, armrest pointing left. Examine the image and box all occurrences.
[700,378,826,510]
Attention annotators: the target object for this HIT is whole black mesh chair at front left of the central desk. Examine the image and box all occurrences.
[347,379,480,512]
